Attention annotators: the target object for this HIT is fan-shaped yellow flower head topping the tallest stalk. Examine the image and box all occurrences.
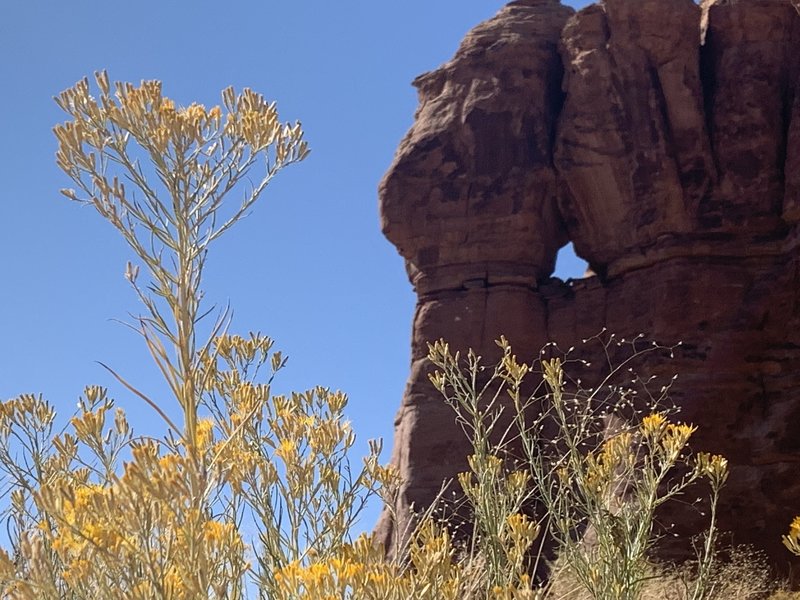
[54,72,308,232]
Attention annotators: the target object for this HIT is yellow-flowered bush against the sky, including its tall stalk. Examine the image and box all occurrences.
[0,73,393,600]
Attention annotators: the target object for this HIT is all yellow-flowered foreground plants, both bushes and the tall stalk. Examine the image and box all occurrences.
[0,73,800,600]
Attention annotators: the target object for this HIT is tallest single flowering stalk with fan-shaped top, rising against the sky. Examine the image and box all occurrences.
[54,72,308,448]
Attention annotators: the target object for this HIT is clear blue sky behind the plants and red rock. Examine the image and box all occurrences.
[0,0,586,526]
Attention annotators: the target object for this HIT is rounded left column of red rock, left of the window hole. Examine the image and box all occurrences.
[380,0,573,564]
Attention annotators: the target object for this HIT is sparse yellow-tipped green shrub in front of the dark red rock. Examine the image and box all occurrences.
[429,336,727,599]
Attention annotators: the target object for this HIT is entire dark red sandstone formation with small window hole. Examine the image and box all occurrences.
[379,0,800,567]
